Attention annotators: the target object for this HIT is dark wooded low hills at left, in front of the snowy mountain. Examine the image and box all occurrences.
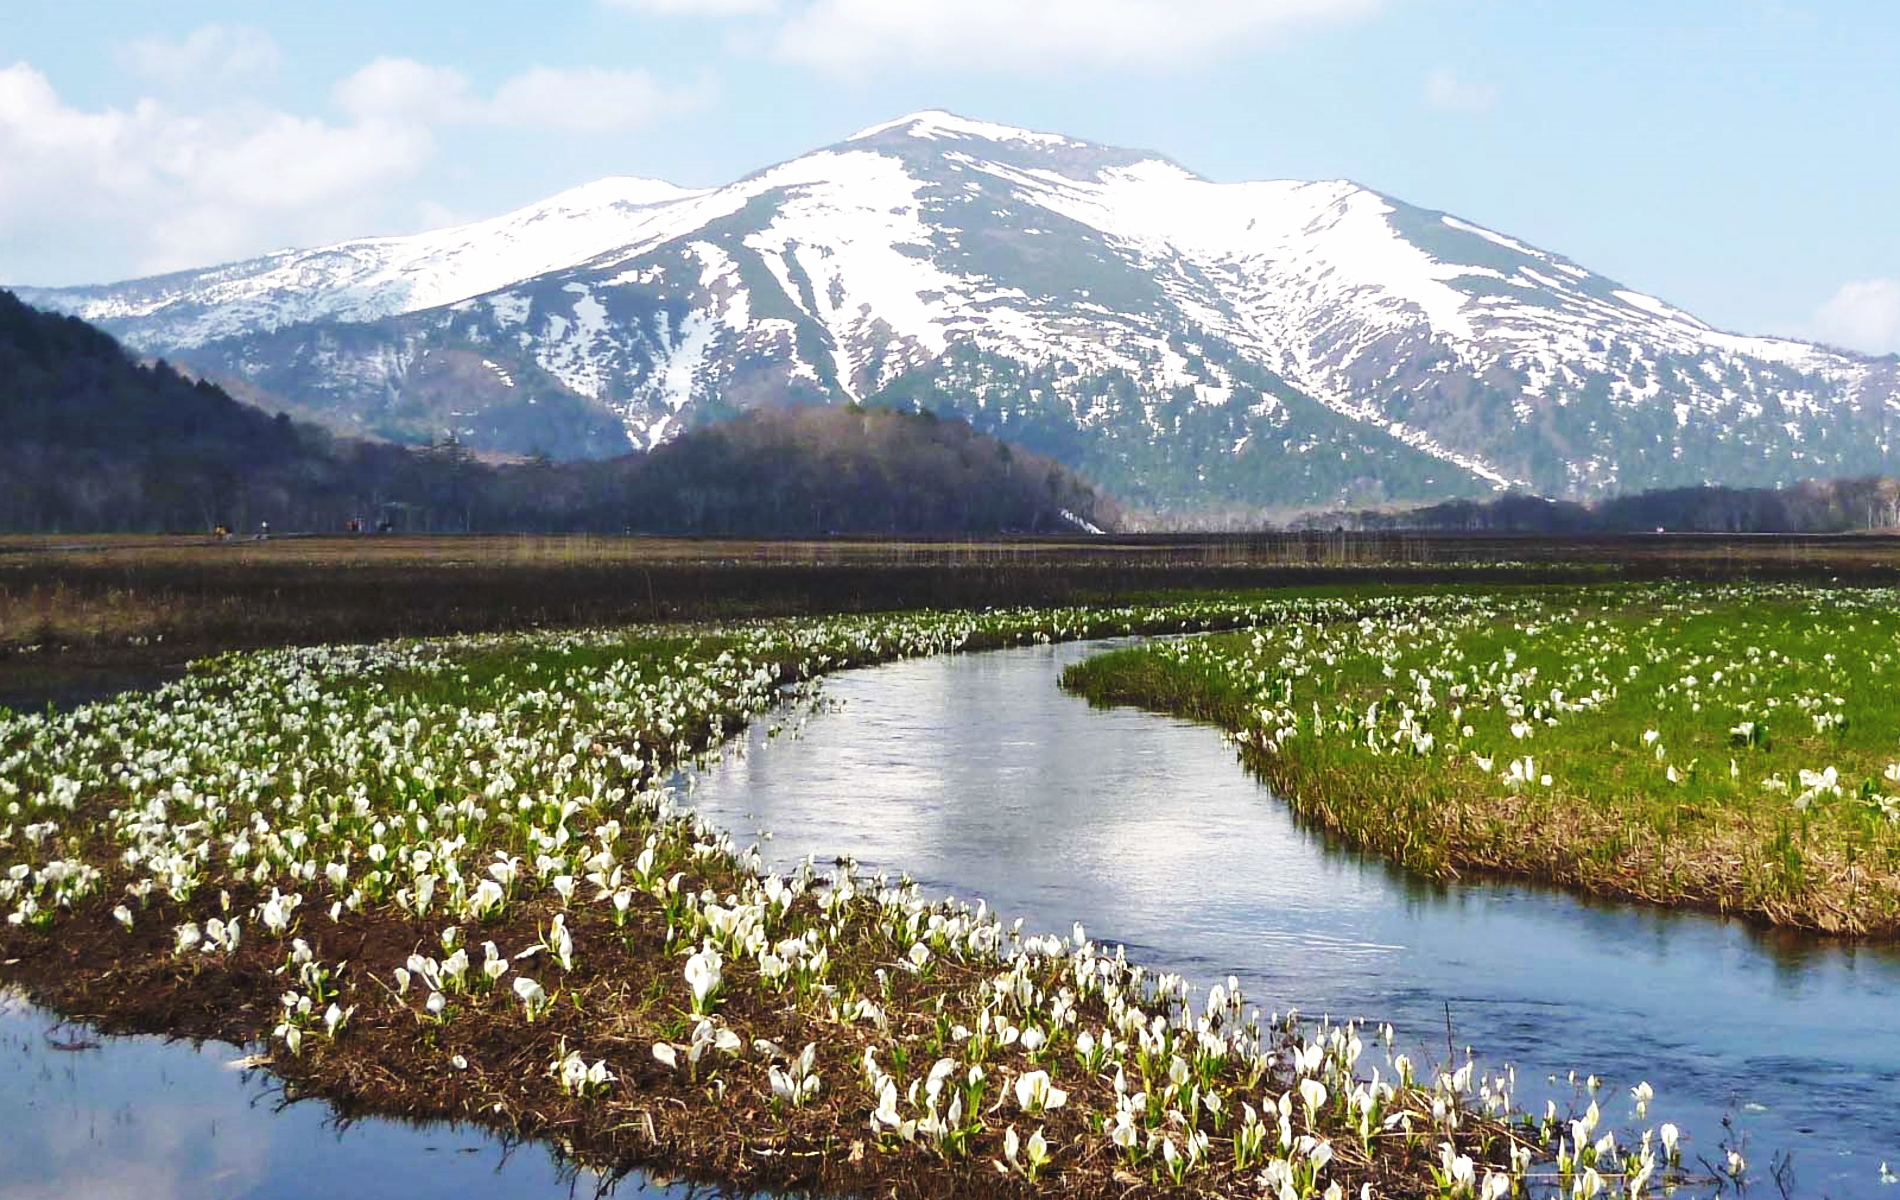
[0,291,1119,535]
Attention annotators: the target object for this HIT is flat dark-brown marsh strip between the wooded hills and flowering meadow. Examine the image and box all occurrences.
[0,534,1900,672]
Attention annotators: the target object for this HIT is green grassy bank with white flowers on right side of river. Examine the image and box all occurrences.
[1066,587,1900,936]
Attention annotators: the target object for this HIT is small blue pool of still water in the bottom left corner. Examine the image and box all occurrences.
[0,993,684,1200]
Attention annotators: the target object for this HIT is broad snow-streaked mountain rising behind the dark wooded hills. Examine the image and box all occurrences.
[23,112,1900,507]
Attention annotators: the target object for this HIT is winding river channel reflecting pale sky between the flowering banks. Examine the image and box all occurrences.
[694,644,1900,1200]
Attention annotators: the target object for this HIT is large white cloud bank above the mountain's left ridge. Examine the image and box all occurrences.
[0,52,711,285]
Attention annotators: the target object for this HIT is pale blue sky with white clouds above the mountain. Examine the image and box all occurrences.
[0,0,1900,351]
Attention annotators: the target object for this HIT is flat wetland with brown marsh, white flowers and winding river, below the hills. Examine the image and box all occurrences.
[0,535,1900,1200]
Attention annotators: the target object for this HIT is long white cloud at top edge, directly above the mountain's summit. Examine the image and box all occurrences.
[775,0,1381,74]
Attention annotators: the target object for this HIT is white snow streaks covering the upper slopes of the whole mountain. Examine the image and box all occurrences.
[37,110,1868,478]
